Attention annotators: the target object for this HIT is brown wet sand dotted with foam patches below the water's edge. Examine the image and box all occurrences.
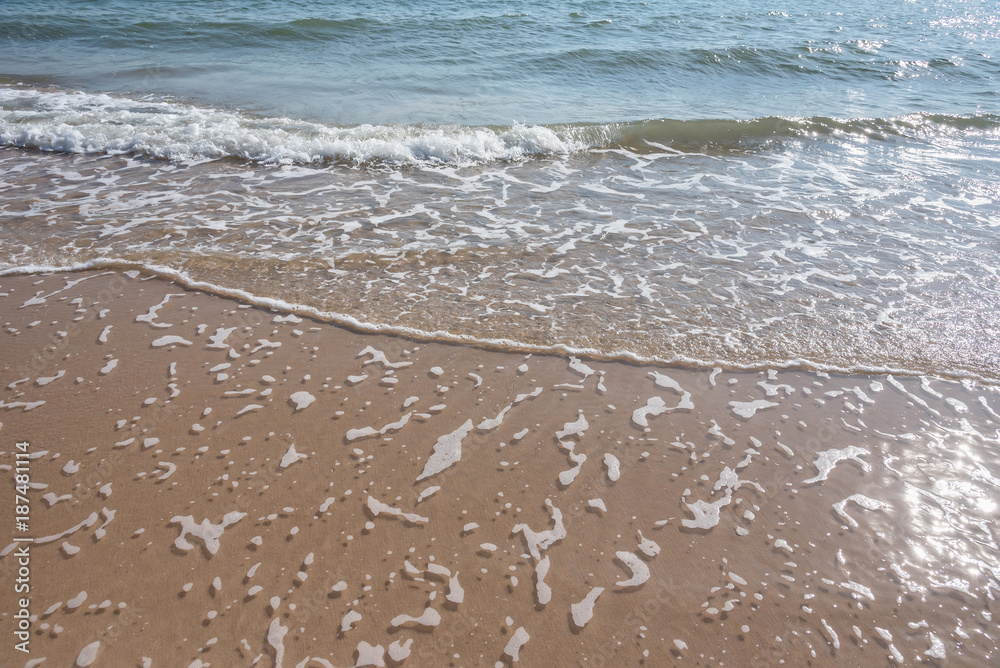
[0,272,1000,668]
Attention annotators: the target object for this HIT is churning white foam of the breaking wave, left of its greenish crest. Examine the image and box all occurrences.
[0,87,584,165]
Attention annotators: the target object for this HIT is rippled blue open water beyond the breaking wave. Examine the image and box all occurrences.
[0,0,1000,125]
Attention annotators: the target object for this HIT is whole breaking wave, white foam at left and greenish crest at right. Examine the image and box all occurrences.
[0,86,1000,165]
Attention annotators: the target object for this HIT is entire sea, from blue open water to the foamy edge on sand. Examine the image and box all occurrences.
[0,0,1000,381]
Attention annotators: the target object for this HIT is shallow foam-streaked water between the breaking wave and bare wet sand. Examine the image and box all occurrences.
[0,120,1000,380]
